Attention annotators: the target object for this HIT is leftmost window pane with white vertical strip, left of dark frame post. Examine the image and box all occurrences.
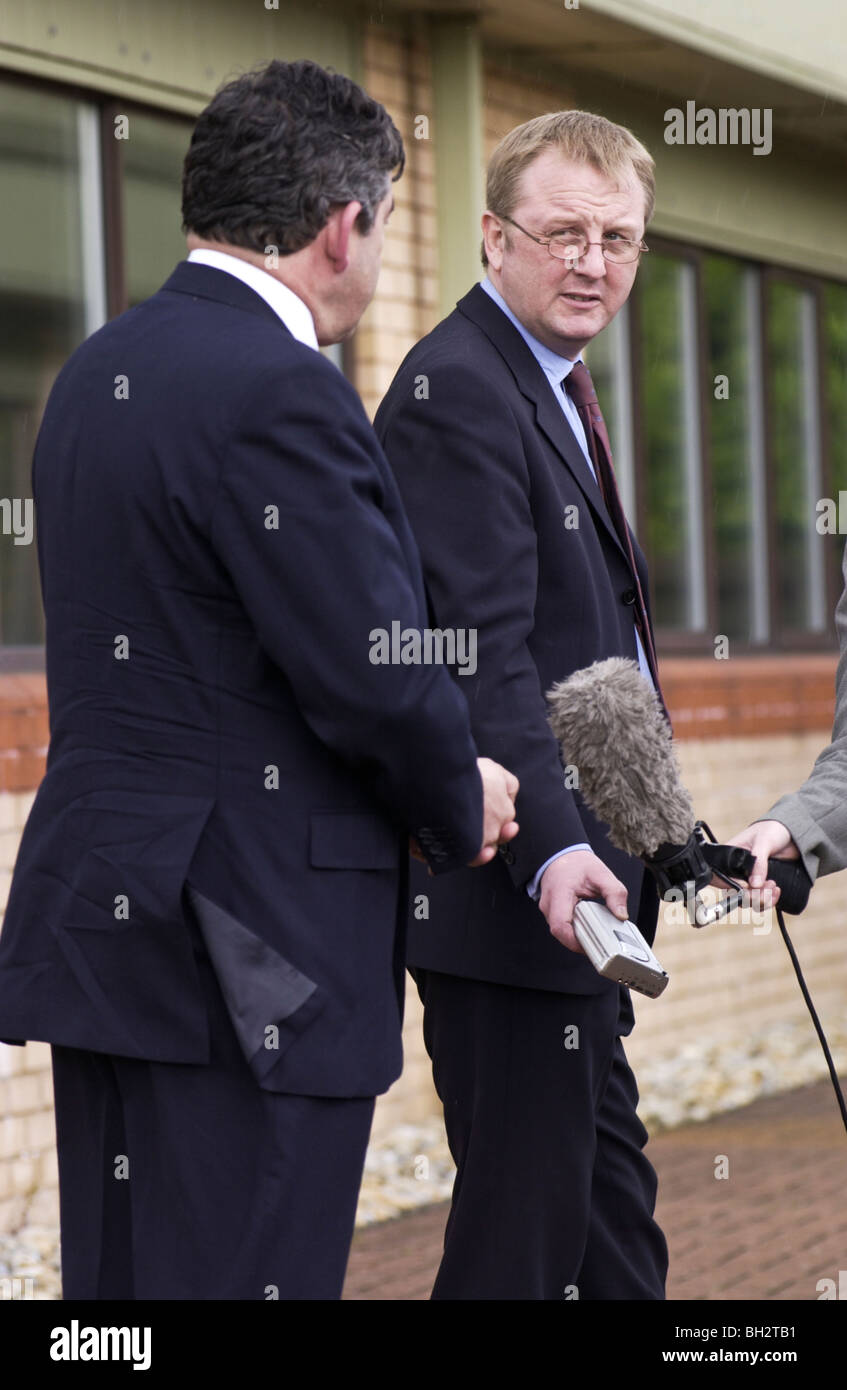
[0,82,106,656]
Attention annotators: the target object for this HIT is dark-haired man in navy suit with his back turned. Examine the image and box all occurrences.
[0,63,517,1300]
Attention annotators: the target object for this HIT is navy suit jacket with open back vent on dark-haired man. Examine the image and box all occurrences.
[0,261,481,1095]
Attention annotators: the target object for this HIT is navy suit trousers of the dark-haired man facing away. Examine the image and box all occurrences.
[53,923,374,1300]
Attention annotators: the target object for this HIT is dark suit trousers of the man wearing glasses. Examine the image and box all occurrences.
[412,969,668,1300]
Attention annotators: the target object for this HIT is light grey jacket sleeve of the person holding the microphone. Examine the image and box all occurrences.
[762,546,847,880]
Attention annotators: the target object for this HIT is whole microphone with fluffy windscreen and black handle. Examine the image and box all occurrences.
[547,656,812,926]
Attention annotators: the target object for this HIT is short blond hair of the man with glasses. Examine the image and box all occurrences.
[483,111,656,265]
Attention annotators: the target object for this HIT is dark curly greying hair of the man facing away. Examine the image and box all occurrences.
[182,58,405,256]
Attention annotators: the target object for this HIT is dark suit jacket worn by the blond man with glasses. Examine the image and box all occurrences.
[376,286,658,994]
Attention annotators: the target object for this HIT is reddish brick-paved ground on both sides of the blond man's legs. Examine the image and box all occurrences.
[344,1079,847,1301]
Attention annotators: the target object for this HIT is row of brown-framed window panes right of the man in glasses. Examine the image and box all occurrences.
[586,238,847,652]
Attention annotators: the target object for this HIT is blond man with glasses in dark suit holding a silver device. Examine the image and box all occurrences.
[376,111,666,1300]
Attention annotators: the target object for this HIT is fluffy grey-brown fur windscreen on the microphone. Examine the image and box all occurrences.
[547,656,694,858]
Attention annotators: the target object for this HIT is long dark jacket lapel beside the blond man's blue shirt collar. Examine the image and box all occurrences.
[456,285,629,564]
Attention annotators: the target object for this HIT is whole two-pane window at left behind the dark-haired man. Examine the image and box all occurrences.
[0,79,191,670]
